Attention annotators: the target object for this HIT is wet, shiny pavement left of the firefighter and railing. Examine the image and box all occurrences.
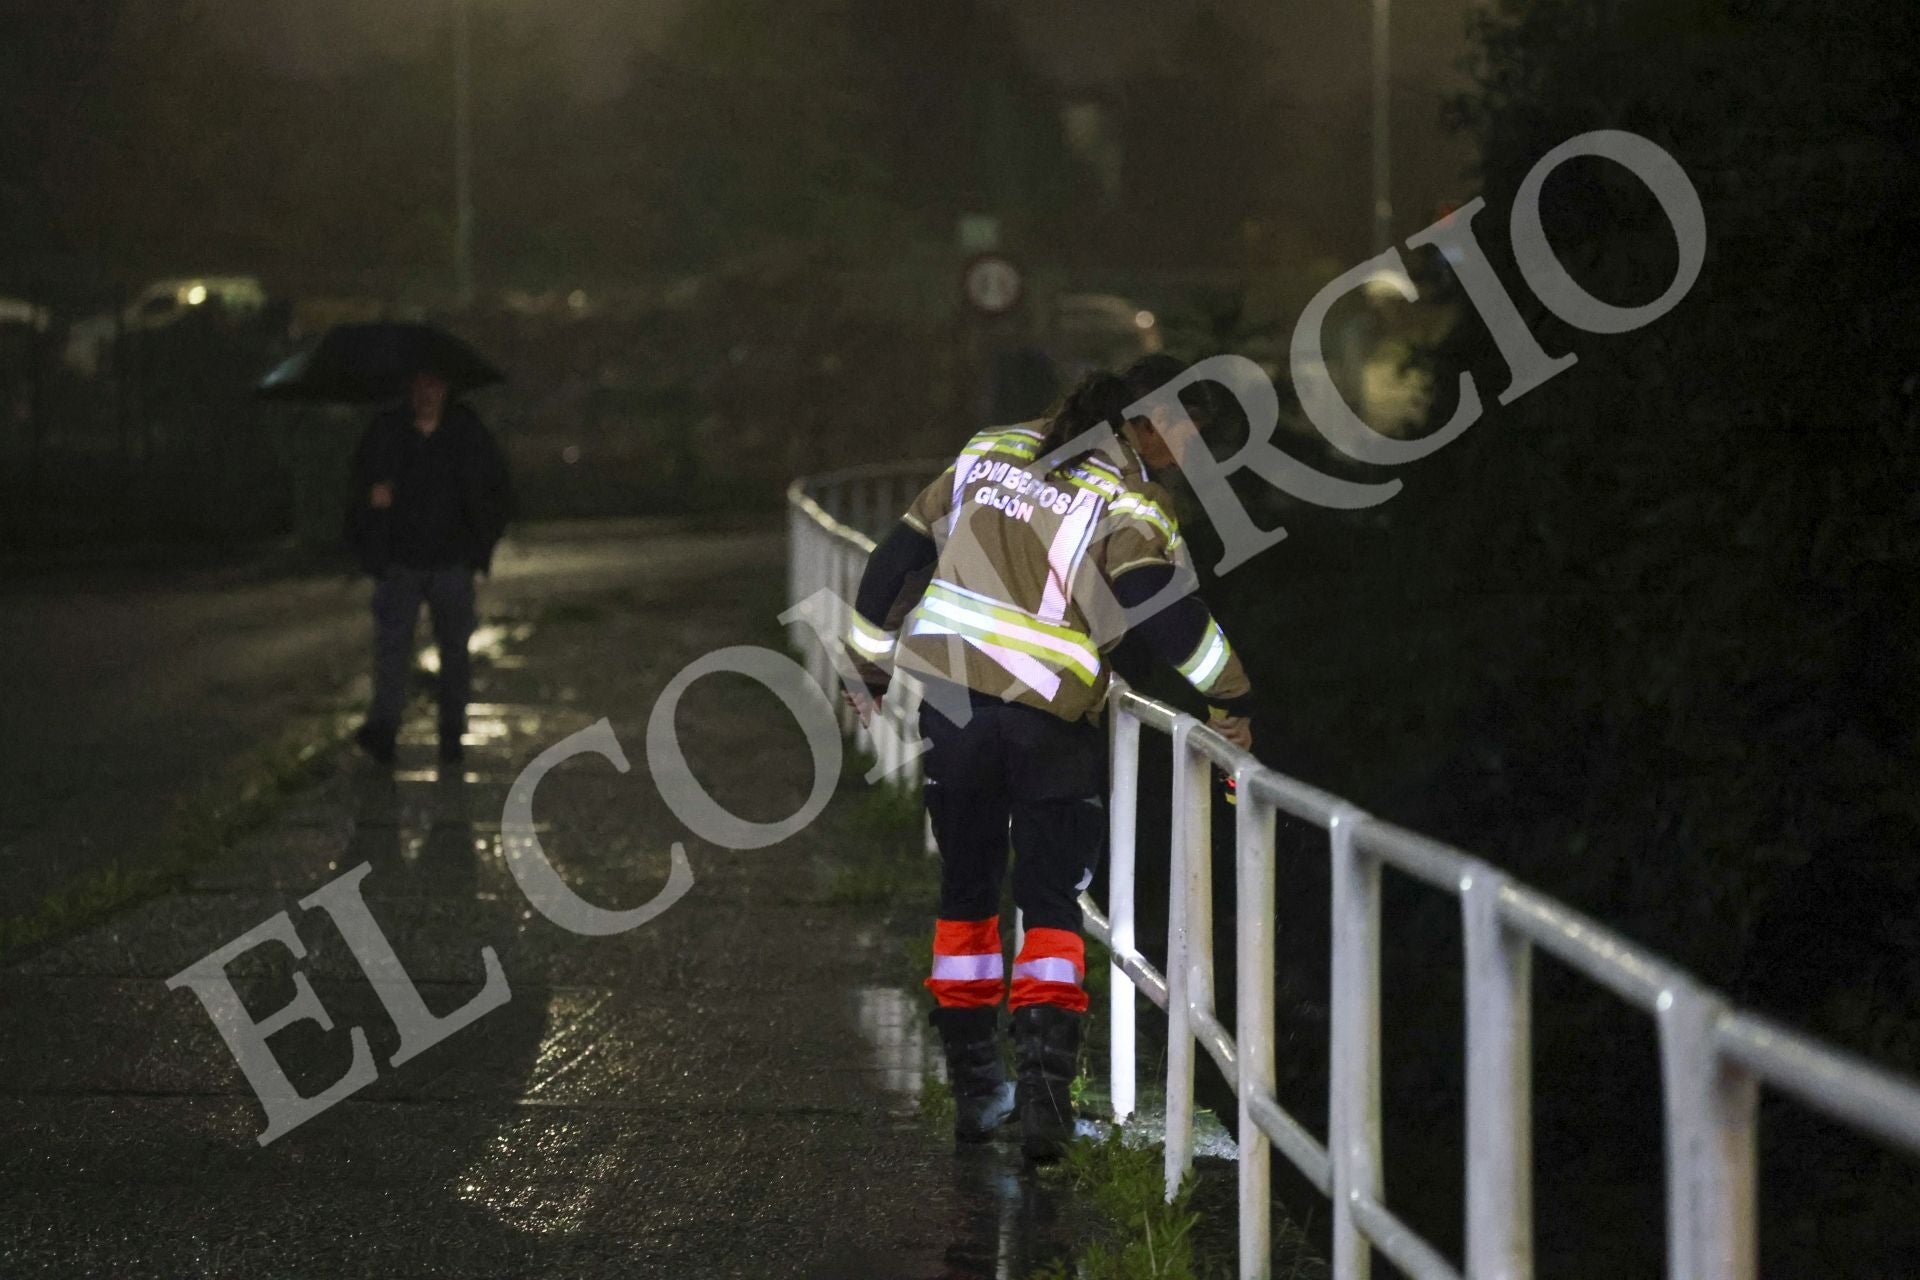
[0,535,1071,1280]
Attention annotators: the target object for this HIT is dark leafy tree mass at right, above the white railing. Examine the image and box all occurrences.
[1421,0,1920,1028]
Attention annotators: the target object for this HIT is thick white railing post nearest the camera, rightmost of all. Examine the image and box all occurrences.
[1655,984,1759,1280]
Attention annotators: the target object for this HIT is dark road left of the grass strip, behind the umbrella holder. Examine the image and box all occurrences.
[0,520,764,917]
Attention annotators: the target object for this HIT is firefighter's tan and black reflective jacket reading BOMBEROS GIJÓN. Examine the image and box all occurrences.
[847,422,1250,720]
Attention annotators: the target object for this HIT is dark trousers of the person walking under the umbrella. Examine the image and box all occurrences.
[367,564,474,739]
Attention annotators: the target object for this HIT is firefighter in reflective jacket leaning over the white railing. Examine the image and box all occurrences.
[847,357,1252,1161]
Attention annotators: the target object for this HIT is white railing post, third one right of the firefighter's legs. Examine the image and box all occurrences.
[1233,766,1273,1280]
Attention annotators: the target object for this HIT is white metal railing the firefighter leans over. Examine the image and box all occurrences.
[789,466,1920,1280]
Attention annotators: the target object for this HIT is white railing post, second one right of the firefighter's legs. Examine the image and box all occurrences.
[1167,716,1208,1201]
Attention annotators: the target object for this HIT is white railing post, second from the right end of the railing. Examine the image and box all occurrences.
[1459,864,1534,1280]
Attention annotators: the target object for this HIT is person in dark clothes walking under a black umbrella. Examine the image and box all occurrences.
[259,324,511,764]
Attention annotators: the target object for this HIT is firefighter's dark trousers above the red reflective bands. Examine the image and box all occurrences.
[920,695,1106,933]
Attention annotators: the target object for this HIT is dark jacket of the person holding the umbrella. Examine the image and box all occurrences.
[346,403,513,576]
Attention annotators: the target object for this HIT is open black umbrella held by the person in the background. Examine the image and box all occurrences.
[253,322,507,405]
